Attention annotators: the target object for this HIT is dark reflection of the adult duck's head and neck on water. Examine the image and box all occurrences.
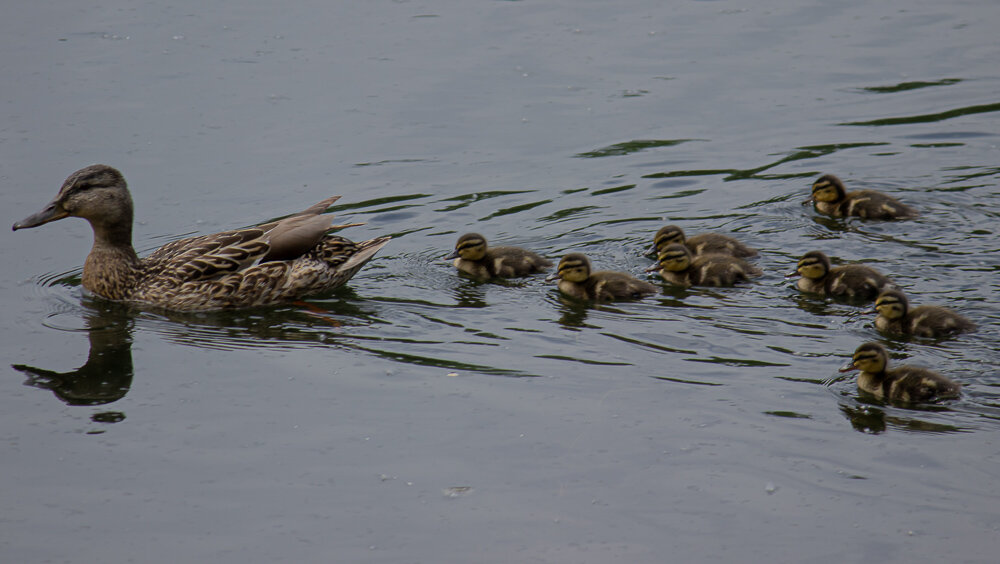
[13,304,134,405]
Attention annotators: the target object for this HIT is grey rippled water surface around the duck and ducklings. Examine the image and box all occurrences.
[0,0,1000,563]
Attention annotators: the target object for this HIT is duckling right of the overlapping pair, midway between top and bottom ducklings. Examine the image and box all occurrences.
[787,251,896,300]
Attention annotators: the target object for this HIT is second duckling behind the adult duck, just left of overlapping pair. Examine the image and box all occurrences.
[548,253,657,302]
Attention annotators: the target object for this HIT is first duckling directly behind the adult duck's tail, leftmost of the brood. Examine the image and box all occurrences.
[445,233,552,278]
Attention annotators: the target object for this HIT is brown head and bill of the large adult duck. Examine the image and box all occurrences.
[13,164,132,235]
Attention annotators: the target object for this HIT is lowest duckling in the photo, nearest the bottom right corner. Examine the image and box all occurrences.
[840,343,961,403]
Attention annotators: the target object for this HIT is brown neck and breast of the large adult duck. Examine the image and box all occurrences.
[83,218,142,300]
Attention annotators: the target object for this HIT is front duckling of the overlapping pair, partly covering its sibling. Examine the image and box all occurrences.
[646,243,762,288]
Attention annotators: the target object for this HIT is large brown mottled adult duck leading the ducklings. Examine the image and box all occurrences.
[14,165,389,311]
